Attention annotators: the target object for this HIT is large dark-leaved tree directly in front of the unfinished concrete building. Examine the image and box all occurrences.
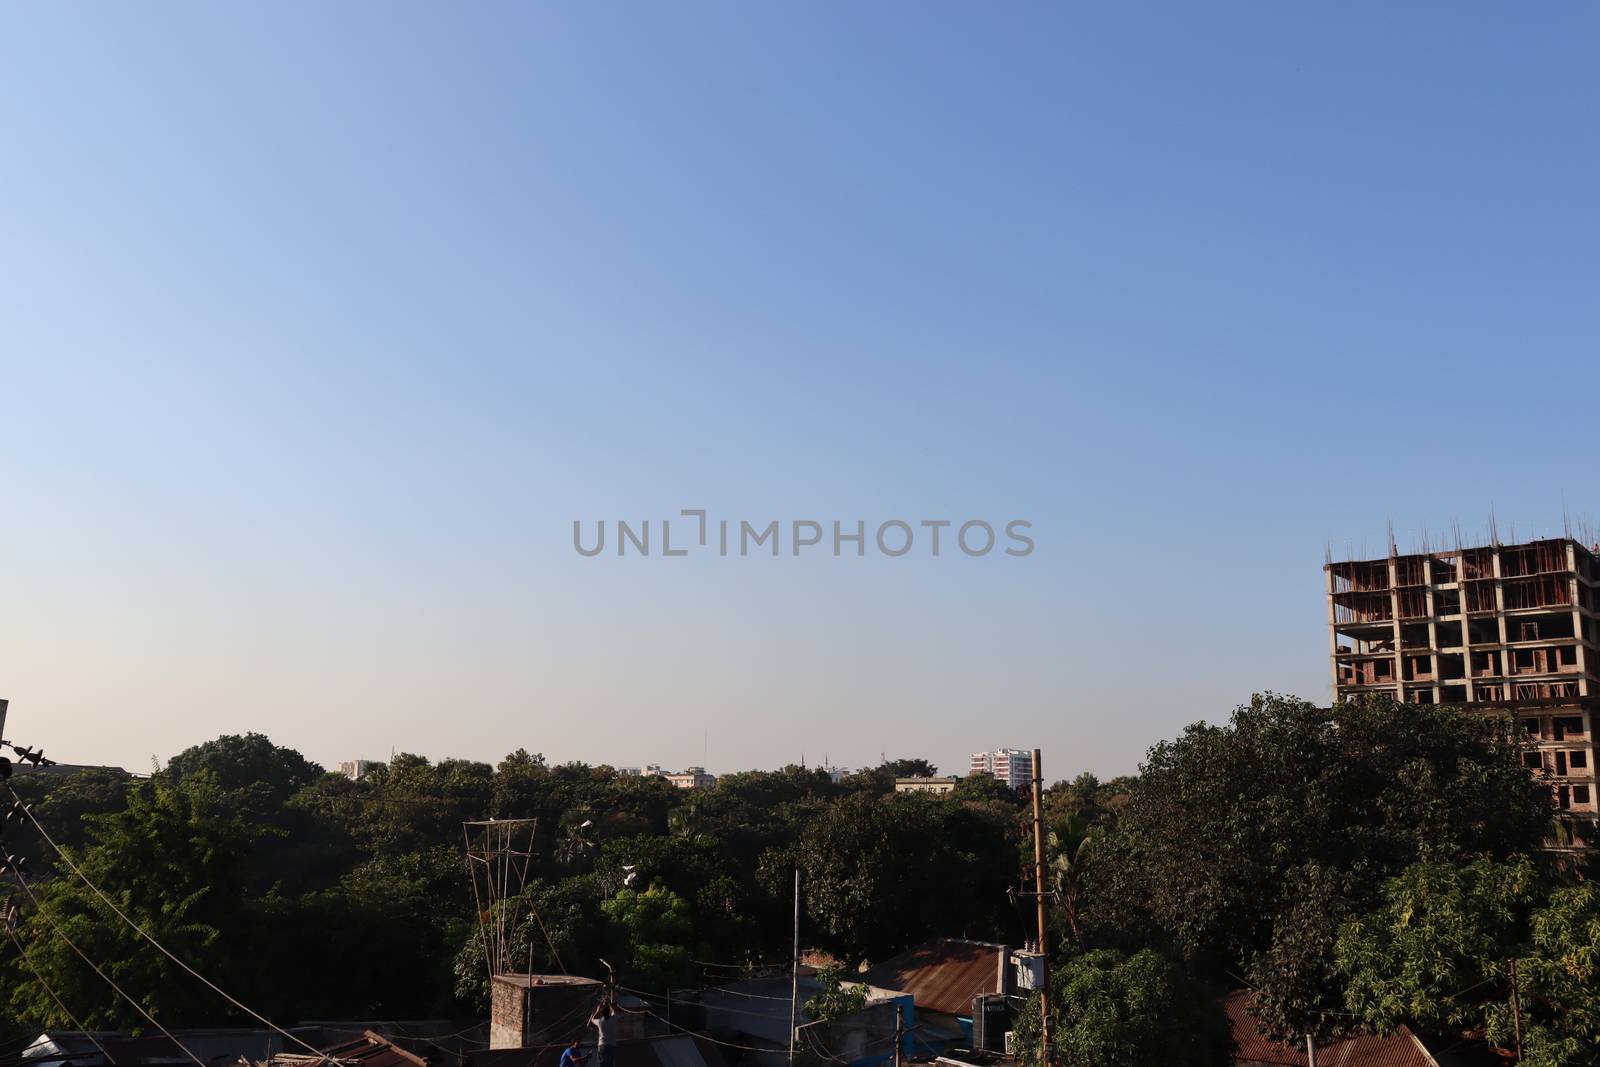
[1085,694,1550,1032]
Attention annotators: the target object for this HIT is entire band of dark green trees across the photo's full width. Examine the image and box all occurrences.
[0,694,1568,1067]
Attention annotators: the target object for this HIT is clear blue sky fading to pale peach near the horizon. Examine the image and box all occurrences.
[0,3,1600,777]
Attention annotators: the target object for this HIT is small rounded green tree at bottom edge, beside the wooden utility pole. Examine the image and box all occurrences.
[1016,949,1230,1067]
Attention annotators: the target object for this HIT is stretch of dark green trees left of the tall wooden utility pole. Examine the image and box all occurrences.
[0,734,1027,1029]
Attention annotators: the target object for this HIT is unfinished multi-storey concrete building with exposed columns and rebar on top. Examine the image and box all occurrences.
[1323,537,1600,845]
